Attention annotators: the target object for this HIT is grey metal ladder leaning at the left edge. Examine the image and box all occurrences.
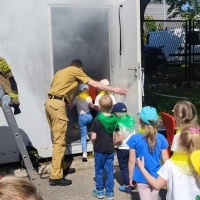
[0,85,39,187]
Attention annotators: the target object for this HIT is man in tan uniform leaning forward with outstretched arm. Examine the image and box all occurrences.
[45,59,127,186]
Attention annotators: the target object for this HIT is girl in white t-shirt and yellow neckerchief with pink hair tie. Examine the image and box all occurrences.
[137,125,200,200]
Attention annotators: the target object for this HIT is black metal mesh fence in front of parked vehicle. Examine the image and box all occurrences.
[143,20,200,80]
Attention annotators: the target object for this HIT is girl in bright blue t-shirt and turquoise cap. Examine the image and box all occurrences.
[127,106,169,200]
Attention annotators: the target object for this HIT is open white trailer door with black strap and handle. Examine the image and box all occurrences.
[109,0,142,126]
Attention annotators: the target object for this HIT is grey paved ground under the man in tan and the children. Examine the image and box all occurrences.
[0,156,166,200]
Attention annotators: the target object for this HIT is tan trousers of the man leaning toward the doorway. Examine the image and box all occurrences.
[45,99,68,179]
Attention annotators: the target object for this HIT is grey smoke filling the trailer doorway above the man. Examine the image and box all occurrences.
[51,7,109,79]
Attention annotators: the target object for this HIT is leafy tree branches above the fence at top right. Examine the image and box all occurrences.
[166,0,200,19]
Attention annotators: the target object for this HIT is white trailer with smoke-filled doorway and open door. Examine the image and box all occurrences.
[0,0,142,164]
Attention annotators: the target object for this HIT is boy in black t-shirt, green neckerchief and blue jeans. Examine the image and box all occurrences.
[90,95,117,199]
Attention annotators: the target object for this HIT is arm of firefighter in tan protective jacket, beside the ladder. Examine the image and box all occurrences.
[0,57,21,115]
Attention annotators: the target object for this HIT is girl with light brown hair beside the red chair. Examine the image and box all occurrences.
[171,101,198,151]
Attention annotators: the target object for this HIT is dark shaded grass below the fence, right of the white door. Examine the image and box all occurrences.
[143,62,200,118]
